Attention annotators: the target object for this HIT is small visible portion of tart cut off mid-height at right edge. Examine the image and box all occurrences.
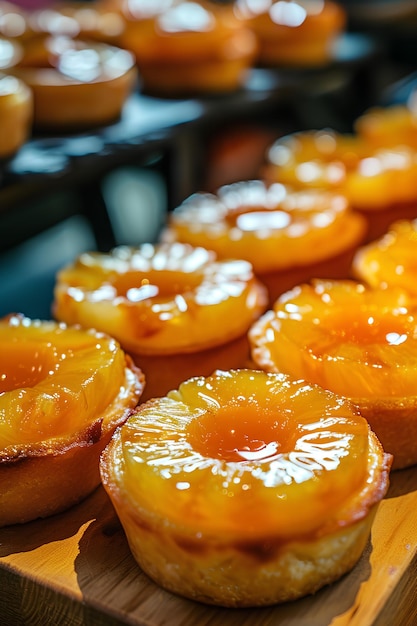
[352,220,417,298]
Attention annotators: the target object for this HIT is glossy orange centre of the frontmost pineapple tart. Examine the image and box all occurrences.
[187,403,291,462]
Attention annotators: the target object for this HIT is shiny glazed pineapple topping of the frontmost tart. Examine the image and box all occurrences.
[113,370,369,540]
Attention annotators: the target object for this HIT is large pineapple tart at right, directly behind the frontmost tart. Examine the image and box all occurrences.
[249,280,417,469]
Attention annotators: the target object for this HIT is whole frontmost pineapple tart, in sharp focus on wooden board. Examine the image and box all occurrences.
[100,370,391,607]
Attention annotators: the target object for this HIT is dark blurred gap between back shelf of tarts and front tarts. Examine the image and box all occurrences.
[0,0,417,318]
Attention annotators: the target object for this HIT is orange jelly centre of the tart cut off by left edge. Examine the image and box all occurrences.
[0,342,56,394]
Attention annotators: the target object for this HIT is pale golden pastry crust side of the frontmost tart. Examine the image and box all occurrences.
[105,468,377,608]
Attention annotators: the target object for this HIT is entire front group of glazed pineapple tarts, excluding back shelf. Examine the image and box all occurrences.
[4,3,417,607]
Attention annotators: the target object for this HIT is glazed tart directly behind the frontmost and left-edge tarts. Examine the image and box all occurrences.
[53,243,267,399]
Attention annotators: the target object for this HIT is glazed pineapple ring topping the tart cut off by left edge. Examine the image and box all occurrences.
[0,315,141,450]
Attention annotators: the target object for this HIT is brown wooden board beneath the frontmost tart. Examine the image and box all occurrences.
[0,468,417,626]
